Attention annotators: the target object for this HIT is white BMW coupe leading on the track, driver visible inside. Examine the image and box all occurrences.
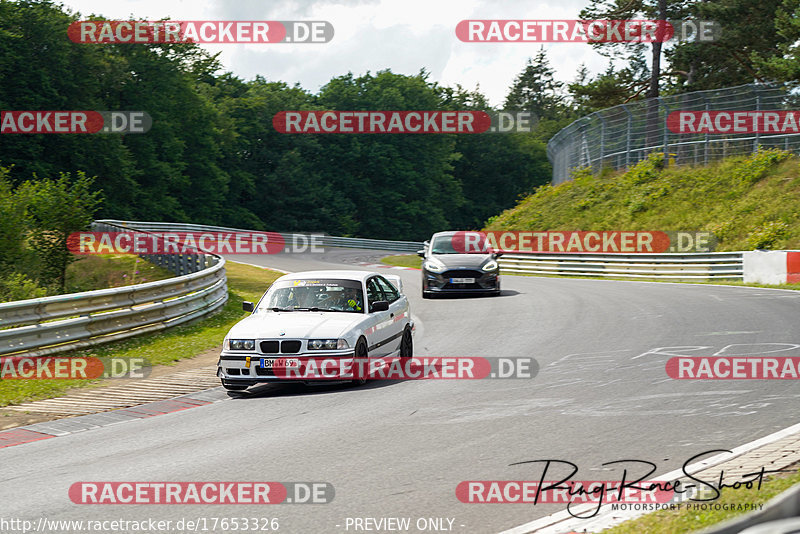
[217,271,414,391]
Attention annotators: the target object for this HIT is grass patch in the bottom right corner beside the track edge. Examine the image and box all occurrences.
[603,473,800,534]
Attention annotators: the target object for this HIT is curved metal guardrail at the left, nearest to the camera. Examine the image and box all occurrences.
[0,222,228,357]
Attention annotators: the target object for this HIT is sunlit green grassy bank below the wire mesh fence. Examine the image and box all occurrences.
[486,150,800,251]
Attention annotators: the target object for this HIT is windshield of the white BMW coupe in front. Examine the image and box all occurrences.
[257,279,364,313]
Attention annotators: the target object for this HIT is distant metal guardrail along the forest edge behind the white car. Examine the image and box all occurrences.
[96,219,422,252]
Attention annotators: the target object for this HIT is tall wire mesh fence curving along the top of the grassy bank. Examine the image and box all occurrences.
[547,84,800,185]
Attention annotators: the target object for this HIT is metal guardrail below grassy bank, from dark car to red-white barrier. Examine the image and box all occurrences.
[499,252,743,279]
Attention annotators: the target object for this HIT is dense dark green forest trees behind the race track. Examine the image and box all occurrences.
[0,0,800,250]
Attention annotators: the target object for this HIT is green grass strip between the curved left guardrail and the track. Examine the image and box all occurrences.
[0,262,282,406]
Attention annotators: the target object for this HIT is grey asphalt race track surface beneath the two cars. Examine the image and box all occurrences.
[0,249,800,533]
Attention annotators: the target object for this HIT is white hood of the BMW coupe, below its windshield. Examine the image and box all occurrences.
[228,311,365,339]
